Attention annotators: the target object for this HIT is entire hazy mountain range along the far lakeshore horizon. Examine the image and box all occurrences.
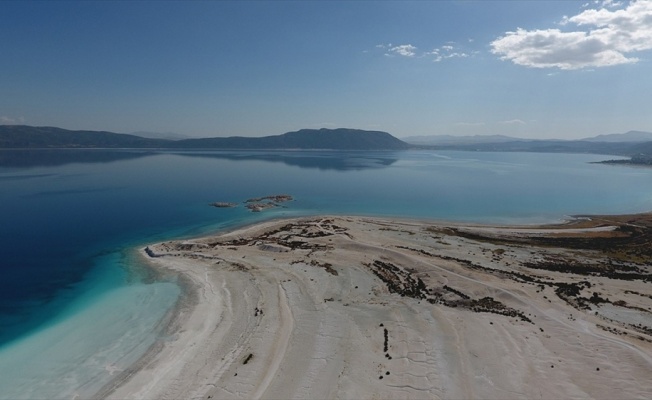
[0,125,652,164]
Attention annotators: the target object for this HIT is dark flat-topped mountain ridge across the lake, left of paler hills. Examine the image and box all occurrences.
[0,125,409,150]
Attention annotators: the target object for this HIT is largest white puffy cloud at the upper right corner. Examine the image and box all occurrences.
[491,0,652,70]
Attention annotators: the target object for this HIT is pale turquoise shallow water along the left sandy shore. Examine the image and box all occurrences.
[0,254,180,399]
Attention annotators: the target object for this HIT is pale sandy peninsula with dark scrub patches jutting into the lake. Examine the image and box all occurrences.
[100,214,652,399]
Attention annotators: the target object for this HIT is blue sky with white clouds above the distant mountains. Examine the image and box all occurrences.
[0,0,652,139]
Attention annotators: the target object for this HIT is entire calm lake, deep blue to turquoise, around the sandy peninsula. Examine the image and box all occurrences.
[0,150,652,398]
